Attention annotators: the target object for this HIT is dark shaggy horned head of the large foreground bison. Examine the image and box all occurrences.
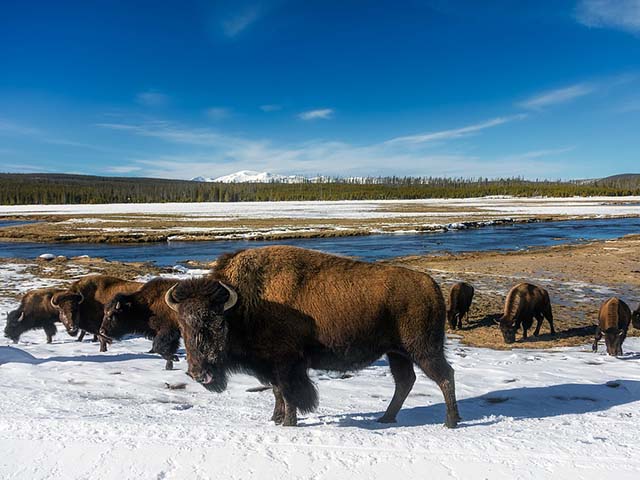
[165,278,238,392]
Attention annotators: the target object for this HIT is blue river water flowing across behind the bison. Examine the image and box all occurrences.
[0,218,640,265]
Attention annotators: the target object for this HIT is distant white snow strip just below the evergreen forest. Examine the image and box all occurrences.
[0,197,640,220]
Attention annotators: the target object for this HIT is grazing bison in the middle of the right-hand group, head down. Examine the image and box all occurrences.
[498,283,556,343]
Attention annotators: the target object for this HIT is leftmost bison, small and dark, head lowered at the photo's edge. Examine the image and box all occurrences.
[4,288,62,343]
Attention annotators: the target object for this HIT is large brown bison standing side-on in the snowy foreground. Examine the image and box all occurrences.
[166,246,460,427]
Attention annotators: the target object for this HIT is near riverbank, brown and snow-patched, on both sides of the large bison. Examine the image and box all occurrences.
[0,235,640,349]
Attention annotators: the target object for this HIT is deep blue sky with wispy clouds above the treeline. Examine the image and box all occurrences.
[0,0,640,179]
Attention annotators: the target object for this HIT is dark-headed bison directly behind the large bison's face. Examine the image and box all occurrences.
[100,278,180,370]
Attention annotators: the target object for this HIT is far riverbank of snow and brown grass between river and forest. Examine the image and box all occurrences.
[0,197,640,244]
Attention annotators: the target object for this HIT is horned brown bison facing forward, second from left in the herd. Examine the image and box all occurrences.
[51,275,142,352]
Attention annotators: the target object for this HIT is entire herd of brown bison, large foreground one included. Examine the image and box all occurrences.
[5,246,640,427]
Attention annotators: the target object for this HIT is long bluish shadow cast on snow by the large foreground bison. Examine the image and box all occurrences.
[319,380,640,430]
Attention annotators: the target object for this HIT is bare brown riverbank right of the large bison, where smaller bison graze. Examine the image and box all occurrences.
[393,235,640,349]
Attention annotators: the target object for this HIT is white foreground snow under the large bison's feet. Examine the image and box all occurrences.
[0,264,640,480]
